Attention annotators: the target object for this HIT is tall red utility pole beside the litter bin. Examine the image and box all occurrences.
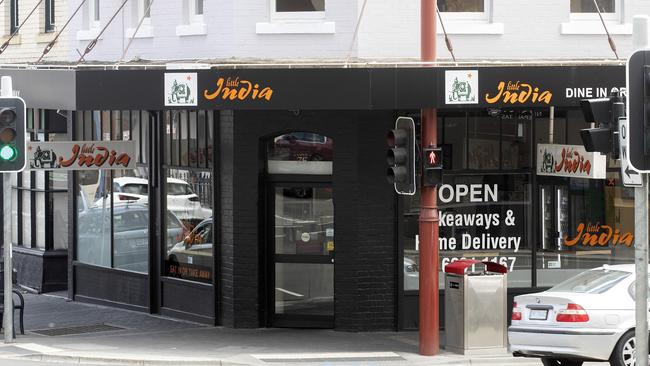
[419,0,440,356]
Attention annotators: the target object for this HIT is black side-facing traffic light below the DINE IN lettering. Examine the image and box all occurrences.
[580,90,625,159]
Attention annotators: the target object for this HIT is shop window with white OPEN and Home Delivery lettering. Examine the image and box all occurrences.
[402,174,533,291]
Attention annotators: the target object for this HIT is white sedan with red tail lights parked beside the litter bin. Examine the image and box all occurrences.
[508,264,636,366]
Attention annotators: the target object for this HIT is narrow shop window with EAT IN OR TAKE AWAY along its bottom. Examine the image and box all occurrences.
[163,110,217,283]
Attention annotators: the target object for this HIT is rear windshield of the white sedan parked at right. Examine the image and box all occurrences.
[549,269,630,294]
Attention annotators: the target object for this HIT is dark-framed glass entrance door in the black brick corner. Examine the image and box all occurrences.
[269,184,334,328]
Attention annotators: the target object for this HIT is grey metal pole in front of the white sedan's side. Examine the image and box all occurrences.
[634,174,648,366]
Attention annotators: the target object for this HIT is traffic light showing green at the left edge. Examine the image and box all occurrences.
[0,97,27,173]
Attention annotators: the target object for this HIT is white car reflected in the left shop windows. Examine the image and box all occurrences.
[93,177,212,221]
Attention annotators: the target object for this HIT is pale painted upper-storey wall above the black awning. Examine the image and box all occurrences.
[0,0,650,63]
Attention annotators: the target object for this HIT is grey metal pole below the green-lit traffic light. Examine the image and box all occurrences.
[2,173,14,343]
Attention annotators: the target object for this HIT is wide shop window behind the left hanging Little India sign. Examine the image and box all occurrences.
[75,111,151,273]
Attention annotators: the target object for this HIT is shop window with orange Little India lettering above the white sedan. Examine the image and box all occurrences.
[536,109,634,287]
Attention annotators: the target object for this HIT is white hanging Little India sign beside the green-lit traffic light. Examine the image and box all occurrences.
[27,141,135,170]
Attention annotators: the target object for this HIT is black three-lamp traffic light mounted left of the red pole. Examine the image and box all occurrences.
[386,117,416,195]
